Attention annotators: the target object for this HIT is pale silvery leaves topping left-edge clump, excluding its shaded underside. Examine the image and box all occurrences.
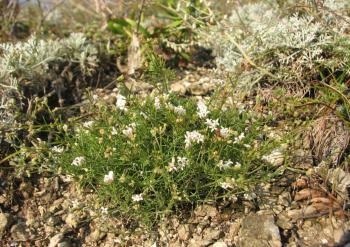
[0,33,98,122]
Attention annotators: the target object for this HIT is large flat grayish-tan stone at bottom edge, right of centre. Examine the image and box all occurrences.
[238,214,282,247]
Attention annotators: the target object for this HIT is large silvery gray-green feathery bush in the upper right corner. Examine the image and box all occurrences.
[205,0,350,90]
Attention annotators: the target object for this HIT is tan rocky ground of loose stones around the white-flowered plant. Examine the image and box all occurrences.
[0,70,350,247]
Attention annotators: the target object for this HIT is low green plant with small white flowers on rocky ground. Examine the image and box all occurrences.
[52,91,275,223]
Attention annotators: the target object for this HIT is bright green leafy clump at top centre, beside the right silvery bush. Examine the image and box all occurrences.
[108,0,214,66]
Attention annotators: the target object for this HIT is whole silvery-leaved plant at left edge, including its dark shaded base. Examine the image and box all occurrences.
[0,33,99,164]
